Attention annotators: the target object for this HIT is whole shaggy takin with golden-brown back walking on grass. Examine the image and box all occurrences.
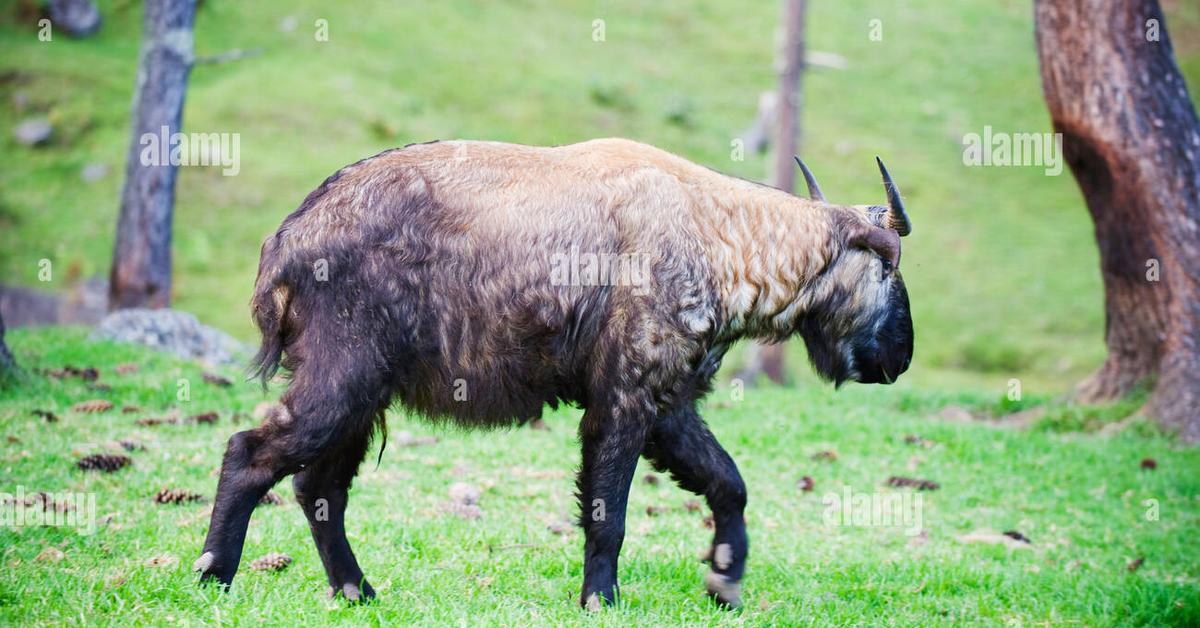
[194,139,913,610]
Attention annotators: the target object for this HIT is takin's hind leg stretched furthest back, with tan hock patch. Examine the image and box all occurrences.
[194,355,383,585]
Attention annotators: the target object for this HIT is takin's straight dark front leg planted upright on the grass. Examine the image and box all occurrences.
[578,401,649,610]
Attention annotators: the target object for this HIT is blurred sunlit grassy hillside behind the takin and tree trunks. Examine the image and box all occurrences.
[9,0,1200,394]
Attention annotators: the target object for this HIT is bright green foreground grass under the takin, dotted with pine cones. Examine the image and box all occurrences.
[0,329,1200,626]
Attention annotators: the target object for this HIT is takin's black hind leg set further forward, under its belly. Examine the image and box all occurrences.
[292,432,374,602]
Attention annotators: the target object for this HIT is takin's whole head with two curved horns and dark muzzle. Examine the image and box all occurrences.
[796,157,913,385]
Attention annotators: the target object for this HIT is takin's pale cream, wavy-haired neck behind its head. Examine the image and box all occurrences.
[697,180,835,340]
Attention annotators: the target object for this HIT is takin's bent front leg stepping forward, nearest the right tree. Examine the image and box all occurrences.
[642,407,750,606]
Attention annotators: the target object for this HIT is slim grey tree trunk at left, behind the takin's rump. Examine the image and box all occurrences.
[109,0,196,310]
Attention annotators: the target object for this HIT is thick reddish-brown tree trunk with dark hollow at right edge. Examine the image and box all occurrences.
[1034,0,1200,441]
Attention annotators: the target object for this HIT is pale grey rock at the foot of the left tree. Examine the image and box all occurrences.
[91,309,250,364]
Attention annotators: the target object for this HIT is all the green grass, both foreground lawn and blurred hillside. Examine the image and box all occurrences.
[0,0,1200,626]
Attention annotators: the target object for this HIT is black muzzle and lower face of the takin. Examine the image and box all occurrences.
[797,273,913,385]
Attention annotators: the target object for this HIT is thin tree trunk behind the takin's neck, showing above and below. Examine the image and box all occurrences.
[743,0,806,384]
